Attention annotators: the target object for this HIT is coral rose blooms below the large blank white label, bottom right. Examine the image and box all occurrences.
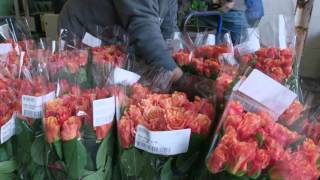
[207,101,320,179]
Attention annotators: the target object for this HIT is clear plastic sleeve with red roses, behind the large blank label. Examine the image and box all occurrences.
[235,14,300,93]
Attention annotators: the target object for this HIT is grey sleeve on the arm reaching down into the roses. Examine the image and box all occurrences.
[113,0,176,70]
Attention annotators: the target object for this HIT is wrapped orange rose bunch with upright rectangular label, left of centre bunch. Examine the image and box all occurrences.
[43,80,115,179]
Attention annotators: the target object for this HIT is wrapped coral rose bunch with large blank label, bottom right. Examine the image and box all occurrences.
[207,70,320,180]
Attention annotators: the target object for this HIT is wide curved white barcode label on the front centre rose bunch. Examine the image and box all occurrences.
[135,125,191,156]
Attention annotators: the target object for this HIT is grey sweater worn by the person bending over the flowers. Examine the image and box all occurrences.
[59,0,178,70]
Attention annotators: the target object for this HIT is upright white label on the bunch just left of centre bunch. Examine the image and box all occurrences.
[93,96,115,127]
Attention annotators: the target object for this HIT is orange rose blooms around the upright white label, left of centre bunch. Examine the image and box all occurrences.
[44,84,112,144]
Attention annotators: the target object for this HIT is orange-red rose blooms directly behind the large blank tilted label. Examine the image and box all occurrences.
[240,48,294,83]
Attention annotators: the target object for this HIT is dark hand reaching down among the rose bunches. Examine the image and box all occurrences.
[172,73,214,98]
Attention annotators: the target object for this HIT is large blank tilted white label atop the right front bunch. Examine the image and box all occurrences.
[238,69,297,119]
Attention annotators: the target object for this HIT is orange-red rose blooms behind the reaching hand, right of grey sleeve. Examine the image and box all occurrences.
[173,45,230,79]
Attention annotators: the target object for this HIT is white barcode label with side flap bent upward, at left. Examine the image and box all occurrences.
[22,91,55,119]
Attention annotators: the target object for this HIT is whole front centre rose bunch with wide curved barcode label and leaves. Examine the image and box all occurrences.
[118,84,215,179]
